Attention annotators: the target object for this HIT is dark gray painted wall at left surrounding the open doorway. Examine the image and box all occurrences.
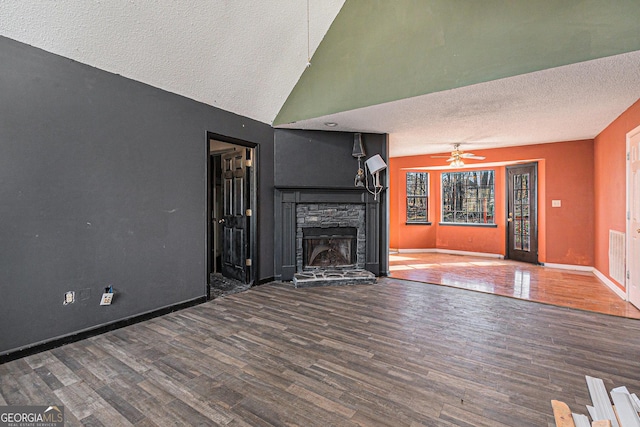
[0,37,274,354]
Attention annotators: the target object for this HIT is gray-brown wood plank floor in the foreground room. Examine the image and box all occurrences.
[0,278,640,427]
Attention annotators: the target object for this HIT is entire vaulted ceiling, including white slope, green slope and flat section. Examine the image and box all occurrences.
[0,0,640,156]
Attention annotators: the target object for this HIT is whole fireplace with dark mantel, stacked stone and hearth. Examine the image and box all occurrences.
[275,189,380,287]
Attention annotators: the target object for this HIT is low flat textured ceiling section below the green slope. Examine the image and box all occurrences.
[281,51,640,157]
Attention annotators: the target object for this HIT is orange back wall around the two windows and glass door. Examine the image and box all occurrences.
[389,140,594,266]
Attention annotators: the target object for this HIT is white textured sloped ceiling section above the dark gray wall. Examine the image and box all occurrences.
[0,0,344,123]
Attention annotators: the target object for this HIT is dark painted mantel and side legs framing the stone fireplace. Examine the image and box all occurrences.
[274,187,386,281]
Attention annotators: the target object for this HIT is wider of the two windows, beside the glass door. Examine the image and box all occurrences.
[442,170,495,224]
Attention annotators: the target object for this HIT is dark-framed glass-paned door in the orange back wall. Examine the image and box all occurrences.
[507,163,538,264]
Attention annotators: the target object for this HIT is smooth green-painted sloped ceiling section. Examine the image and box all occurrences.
[274,0,640,125]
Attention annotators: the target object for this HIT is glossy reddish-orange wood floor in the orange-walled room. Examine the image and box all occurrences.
[389,253,640,319]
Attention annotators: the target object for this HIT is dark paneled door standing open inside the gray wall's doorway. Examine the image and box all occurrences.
[220,148,250,283]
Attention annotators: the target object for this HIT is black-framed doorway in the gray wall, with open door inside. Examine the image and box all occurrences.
[206,133,258,298]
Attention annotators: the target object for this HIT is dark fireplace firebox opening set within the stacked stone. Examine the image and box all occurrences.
[302,227,358,269]
